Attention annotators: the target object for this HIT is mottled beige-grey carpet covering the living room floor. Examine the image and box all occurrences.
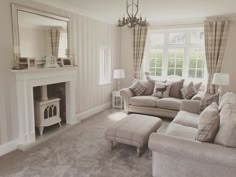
[0,109,168,177]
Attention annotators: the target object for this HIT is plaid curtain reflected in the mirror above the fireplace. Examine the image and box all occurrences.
[49,28,61,57]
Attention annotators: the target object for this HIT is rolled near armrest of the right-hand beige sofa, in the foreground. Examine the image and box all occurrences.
[148,133,236,168]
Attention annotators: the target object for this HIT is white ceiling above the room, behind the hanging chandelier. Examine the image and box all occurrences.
[35,0,236,23]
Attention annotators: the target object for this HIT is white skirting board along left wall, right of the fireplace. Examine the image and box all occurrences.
[76,102,111,121]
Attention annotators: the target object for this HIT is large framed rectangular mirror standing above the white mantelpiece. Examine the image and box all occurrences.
[12,4,72,69]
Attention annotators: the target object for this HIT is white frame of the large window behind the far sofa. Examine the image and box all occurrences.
[144,27,208,81]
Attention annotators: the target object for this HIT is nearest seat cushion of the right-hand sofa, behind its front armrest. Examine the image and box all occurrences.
[166,123,198,140]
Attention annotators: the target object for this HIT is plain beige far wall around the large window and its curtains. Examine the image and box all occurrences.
[120,17,236,92]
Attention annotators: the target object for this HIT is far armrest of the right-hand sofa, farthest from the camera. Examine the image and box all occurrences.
[180,100,200,114]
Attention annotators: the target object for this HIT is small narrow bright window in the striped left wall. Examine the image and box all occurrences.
[99,47,111,85]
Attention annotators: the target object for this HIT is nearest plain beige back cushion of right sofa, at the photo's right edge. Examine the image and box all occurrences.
[215,104,236,148]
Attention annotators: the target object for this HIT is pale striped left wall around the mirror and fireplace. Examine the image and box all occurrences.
[0,0,119,154]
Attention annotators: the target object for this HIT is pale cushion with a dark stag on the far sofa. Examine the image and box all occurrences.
[152,82,171,98]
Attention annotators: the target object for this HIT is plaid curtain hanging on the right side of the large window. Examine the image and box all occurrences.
[204,20,230,94]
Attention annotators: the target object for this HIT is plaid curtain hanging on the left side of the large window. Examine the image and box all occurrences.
[133,25,148,79]
